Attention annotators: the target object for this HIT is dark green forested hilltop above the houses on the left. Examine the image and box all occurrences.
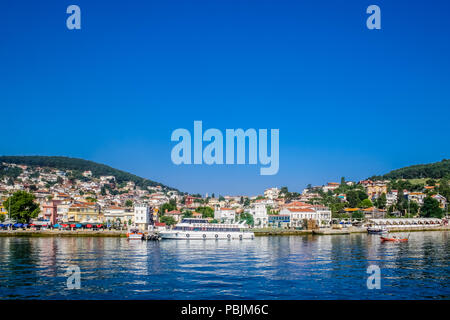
[0,156,176,190]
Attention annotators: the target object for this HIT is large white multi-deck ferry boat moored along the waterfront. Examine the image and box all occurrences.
[159,218,255,240]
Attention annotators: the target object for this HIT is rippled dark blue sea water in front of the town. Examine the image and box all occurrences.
[0,232,450,299]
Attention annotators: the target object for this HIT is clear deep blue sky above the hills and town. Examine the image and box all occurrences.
[0,0,450,195]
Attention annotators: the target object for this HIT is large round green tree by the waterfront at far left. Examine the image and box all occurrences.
[3,191,40,223]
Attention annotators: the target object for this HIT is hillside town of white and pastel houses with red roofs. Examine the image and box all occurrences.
[0,163,447,230]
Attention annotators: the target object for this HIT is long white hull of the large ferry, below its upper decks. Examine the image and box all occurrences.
[159,230,255,240]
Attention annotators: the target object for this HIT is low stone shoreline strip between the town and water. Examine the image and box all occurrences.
[0,226,450,238]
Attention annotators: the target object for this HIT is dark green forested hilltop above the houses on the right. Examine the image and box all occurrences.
[370,159,450,180]
